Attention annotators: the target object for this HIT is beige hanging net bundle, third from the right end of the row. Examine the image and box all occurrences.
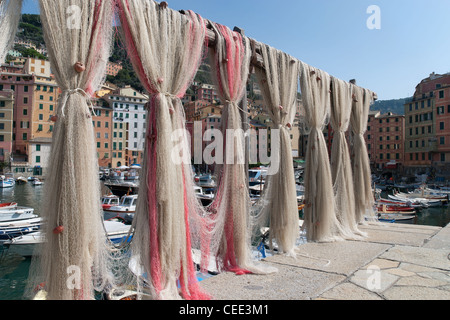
[300,62,344,242]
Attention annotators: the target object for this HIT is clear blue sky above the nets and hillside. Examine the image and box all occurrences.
[23,0,450,100]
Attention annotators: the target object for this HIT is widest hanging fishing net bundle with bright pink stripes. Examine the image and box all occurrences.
[117,0,208,299]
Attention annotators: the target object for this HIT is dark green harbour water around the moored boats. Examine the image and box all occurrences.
[0,183,450,300]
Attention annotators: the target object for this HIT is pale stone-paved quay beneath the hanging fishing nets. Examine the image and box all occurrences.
[201,223,450,300]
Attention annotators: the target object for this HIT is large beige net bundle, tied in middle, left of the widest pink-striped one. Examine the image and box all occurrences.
[28,0,113,300]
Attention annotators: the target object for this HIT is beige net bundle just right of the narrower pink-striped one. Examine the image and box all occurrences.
[254,44,299,255]
